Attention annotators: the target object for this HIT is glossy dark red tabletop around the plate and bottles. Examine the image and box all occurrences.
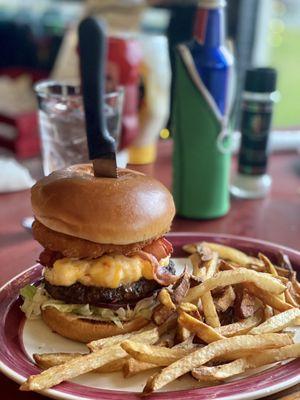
[0,141,300,400]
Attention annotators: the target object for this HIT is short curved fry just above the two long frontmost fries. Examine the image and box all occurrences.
[121,340,197,366]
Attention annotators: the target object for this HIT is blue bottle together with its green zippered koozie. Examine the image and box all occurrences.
[172,0,233,219]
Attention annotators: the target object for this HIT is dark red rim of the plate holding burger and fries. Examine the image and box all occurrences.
[0,232,300,400]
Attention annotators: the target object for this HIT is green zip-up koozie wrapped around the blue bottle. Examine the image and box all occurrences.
[172,45,231,219]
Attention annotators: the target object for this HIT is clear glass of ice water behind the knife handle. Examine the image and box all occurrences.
[35,81,124,175]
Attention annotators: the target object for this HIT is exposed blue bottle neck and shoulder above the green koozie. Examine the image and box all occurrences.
[187,0,233,116]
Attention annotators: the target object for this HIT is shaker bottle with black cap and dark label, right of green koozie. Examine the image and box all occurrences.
[231,68,278,199]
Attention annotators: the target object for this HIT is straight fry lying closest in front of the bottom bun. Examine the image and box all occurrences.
[87,324,159,351]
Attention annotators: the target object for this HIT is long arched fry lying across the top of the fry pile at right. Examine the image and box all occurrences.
[184,268,286,303]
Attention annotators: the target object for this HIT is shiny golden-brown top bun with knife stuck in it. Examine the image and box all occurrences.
[31,164,175,245]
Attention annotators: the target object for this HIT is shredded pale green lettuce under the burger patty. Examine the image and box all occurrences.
[20,285,157,327]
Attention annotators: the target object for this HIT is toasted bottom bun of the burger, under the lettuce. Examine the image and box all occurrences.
[42,307,149,343]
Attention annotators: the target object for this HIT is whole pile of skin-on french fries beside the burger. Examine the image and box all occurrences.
[20,242,300,394]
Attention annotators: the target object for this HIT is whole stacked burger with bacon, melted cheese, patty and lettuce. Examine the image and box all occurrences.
[21,164,178,342]
